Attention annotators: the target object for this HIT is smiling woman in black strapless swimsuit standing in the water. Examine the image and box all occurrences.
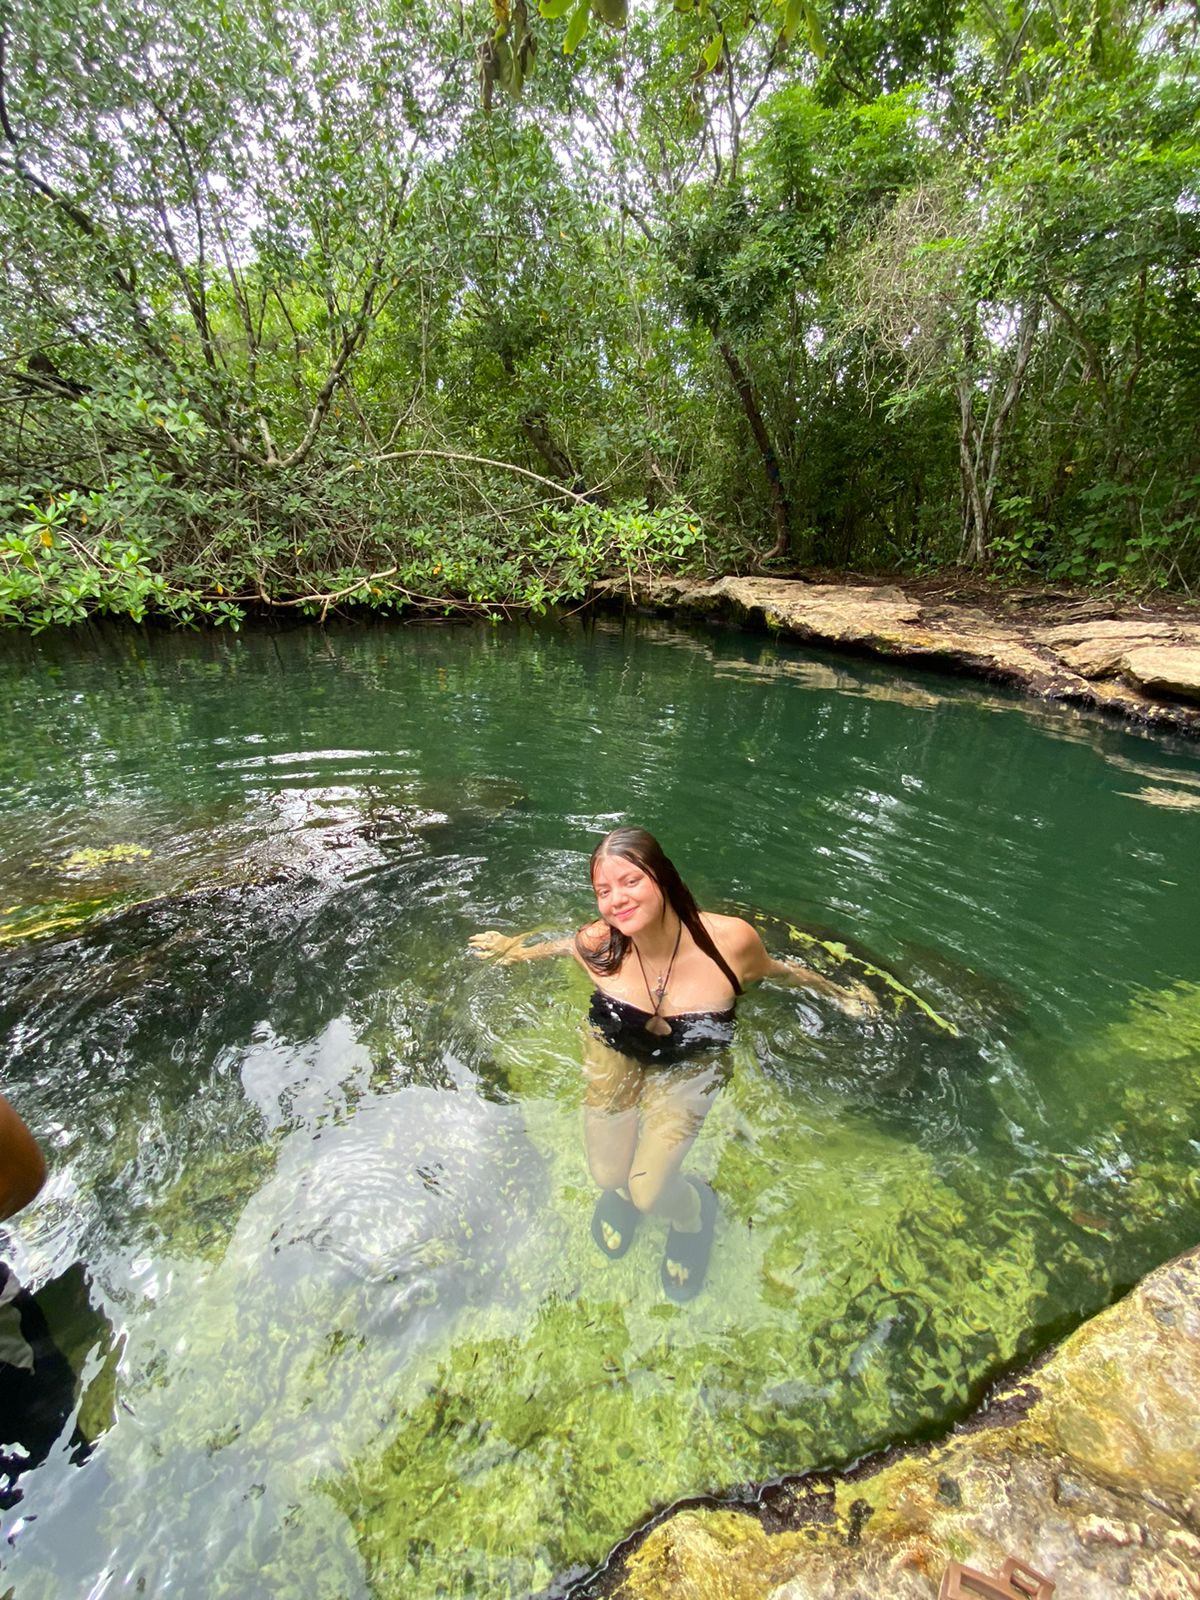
[470,827,875,1301]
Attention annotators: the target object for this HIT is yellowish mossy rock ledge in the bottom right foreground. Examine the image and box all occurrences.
[603,1248,1200,1600]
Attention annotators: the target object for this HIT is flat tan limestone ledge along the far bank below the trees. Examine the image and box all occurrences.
[598,578,1200,734]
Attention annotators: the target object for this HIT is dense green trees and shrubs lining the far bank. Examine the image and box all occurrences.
[0,0,1200,630]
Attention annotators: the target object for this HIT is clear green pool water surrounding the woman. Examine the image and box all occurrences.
[0,622,1200,1600]
